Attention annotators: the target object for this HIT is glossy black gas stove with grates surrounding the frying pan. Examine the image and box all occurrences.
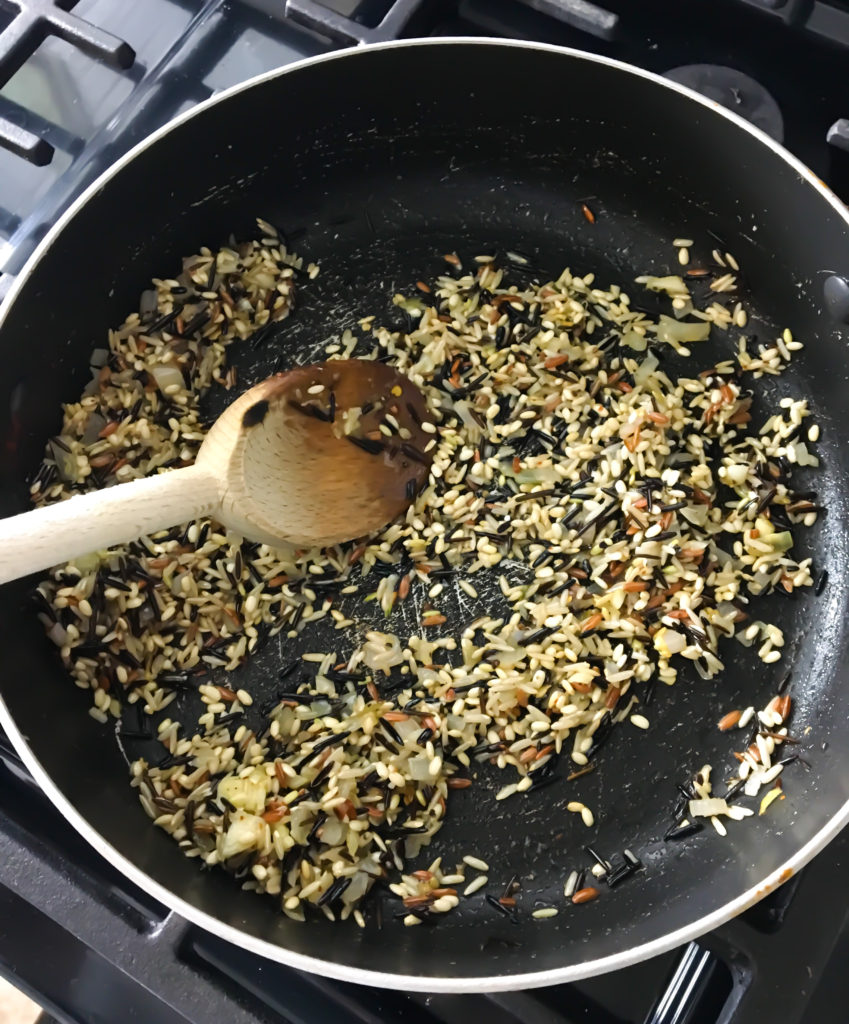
[0,0,849,1024]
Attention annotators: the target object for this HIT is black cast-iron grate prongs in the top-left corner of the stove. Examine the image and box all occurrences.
[0,0,135,167]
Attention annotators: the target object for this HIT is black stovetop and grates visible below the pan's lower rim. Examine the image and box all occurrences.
[0,732,849,1024]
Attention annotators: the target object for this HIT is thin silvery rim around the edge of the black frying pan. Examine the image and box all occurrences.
[0,36,849,993]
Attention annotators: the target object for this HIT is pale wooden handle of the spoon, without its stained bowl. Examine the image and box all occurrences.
[0,466,220,583]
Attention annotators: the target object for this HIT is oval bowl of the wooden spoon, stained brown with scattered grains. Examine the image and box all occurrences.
[203,359,433,547]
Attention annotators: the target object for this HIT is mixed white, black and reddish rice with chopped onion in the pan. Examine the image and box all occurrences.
[32,221,817,926]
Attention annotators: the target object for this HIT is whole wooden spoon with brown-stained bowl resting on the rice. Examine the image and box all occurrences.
[0,359,433,583]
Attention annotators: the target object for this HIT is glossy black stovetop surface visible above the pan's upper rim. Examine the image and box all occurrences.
[0,0,849,287]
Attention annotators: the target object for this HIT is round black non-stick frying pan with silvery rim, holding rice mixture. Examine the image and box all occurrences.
[0,40,849,990]
